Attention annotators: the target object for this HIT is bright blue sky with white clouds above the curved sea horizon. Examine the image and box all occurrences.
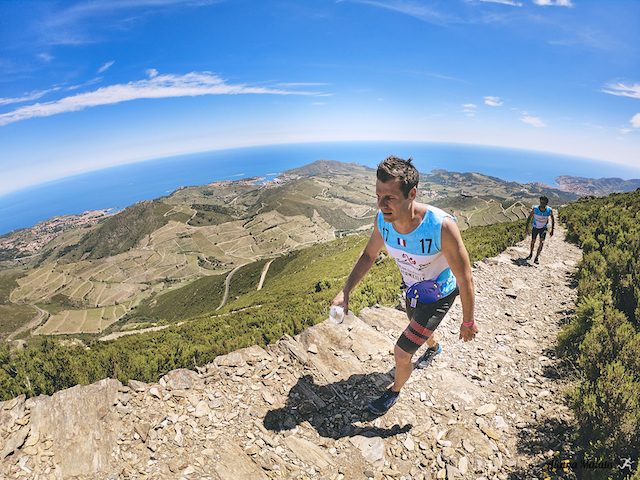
[0,0,640,195]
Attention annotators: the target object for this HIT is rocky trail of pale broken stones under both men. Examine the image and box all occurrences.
[0,228,581,480]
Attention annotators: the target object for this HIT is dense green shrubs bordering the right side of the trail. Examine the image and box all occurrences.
[558,191,640,470]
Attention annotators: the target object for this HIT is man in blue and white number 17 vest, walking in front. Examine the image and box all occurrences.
[332,156,478,415]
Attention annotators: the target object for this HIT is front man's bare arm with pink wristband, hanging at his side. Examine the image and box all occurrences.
[441,217,478,342]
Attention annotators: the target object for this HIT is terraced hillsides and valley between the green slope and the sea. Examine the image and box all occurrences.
[0,160,575,342]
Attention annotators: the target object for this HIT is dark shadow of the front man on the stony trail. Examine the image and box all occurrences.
[263,373,413,439]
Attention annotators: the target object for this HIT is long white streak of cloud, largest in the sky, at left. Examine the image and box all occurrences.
[0,70,318,126]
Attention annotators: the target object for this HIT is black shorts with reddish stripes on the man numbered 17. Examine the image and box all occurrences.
[396,287,460,355]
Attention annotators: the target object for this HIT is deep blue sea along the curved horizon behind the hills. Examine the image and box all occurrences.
[0,142,640,235]
